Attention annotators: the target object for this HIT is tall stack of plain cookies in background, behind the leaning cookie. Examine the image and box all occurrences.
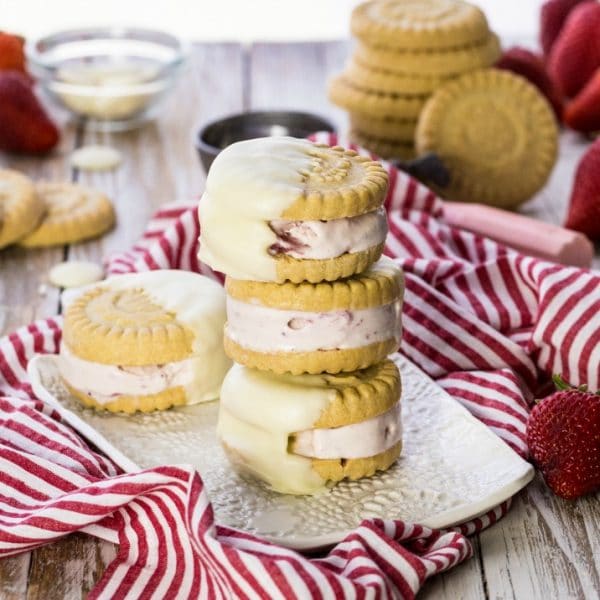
[329,0,501,159]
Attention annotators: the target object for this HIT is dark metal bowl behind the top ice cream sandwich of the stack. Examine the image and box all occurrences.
[196,110,335,173]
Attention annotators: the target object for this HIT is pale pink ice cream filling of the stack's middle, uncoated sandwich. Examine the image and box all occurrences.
[225,296,402,352]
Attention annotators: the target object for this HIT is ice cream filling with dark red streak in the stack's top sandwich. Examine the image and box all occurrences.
[269,208,387,260]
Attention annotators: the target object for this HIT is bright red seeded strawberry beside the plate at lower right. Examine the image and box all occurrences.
[527,379,600,499]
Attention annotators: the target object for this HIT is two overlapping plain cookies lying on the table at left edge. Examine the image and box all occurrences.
[0,169,115,248]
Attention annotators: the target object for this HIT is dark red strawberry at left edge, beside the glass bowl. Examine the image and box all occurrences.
[0,71,59,154]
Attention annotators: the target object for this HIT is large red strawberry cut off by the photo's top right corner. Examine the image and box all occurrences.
[548,2,600,97]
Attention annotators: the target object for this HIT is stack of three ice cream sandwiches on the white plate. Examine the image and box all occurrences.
[200,138,403,494]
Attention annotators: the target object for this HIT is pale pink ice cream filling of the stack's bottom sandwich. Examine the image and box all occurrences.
[291,402,402,459]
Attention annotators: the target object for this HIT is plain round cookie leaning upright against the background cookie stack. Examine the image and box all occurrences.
[416,69,558,208]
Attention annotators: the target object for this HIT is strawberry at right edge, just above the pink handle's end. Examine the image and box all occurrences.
[565,138,600,240]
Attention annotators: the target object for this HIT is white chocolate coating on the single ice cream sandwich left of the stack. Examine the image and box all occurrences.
[61,269,231,404]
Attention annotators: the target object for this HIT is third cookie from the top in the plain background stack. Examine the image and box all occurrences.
[344,57,449,96]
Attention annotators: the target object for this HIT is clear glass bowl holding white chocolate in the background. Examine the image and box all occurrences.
[27,27,186,131]
